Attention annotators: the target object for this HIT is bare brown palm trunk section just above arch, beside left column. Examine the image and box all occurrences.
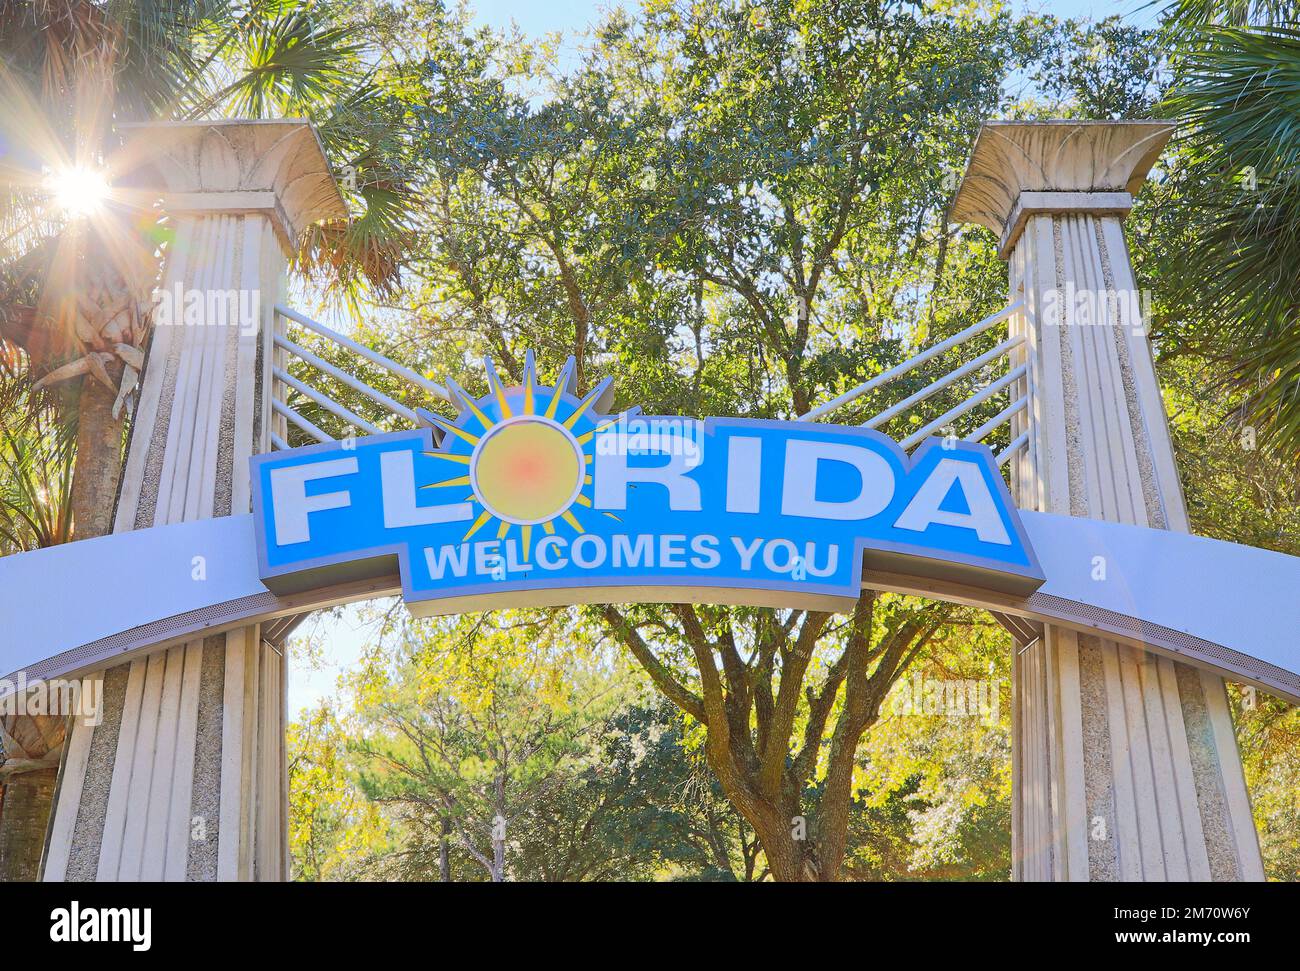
[72,376,126,539]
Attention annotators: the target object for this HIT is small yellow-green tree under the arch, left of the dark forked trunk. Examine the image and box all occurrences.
[352,614,620,880]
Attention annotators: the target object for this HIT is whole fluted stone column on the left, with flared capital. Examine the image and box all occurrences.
[43,120,346,880]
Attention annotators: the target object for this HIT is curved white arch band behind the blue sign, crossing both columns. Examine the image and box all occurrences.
[0,511,1300,703]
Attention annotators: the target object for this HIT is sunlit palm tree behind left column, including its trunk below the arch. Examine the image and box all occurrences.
[0,0,410,880]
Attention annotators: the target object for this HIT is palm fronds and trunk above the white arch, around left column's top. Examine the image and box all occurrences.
[0,0,413,538]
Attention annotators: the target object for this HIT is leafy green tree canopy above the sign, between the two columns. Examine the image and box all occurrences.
[364,3,1023,416]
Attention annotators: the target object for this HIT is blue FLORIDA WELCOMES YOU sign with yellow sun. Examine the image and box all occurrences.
[252,356,1043,614]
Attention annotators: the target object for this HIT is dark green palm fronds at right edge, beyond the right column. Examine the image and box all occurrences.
[1167,0,1300,456]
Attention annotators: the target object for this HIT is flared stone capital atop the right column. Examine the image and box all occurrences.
[949,120,1174,259]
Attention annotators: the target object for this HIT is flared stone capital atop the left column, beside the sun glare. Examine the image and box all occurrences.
[121,118,347,248]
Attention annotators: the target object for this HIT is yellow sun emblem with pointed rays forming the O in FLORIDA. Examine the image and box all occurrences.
[420,351,618,560]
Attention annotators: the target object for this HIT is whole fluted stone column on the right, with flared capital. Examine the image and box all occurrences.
[952,121,1264,880]
